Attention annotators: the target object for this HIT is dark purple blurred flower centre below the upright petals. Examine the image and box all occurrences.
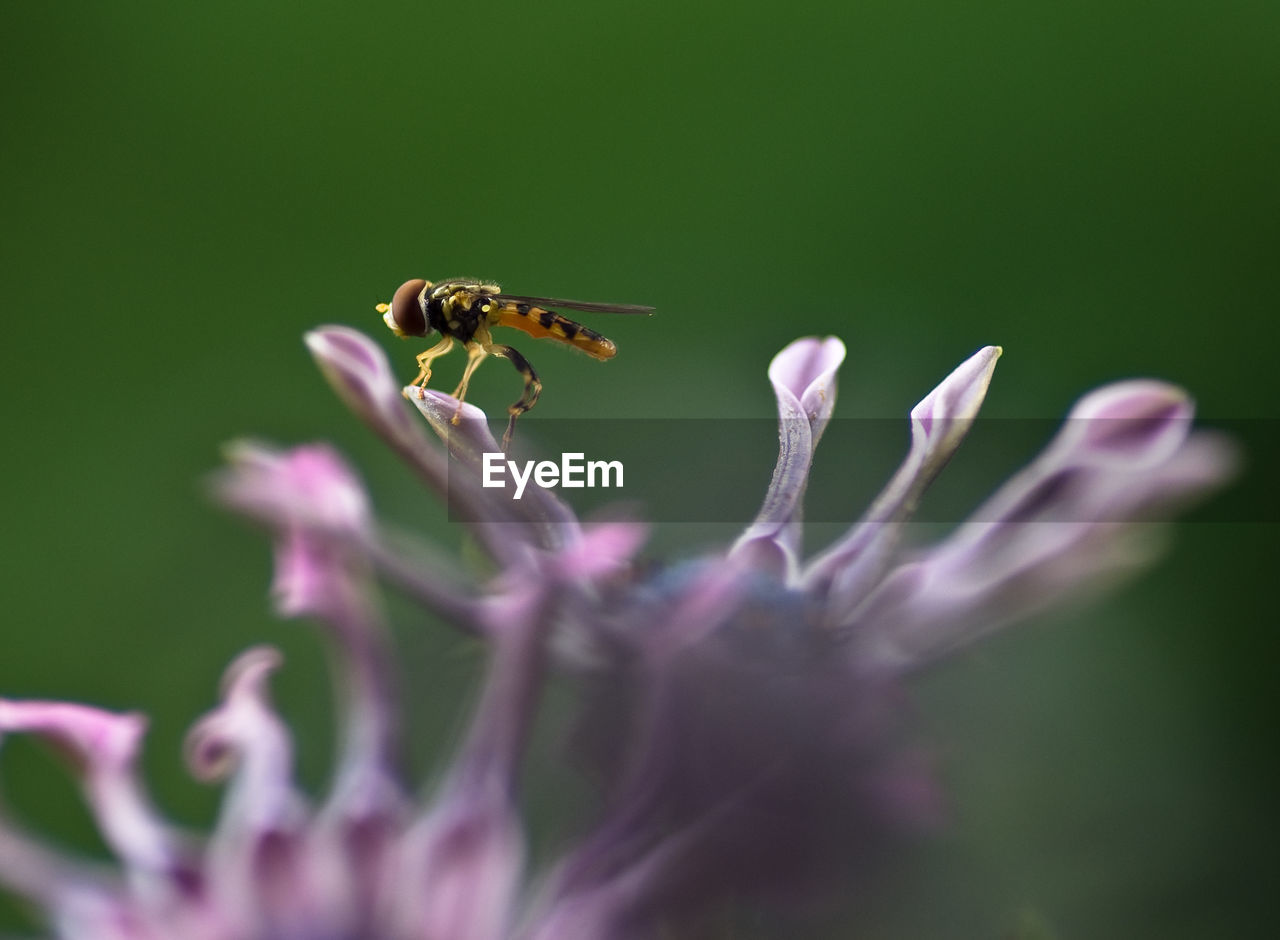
[534,573,932,937]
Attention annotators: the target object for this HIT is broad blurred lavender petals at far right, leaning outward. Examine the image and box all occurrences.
[841,382,1235,669]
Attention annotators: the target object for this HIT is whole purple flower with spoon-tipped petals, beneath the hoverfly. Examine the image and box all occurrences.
[0,328,1231,940]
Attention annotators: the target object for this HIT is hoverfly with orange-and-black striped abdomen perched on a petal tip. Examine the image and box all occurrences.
[378,278,653,451]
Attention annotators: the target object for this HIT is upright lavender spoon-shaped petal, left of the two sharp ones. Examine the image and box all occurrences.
[731,337,845,581]
